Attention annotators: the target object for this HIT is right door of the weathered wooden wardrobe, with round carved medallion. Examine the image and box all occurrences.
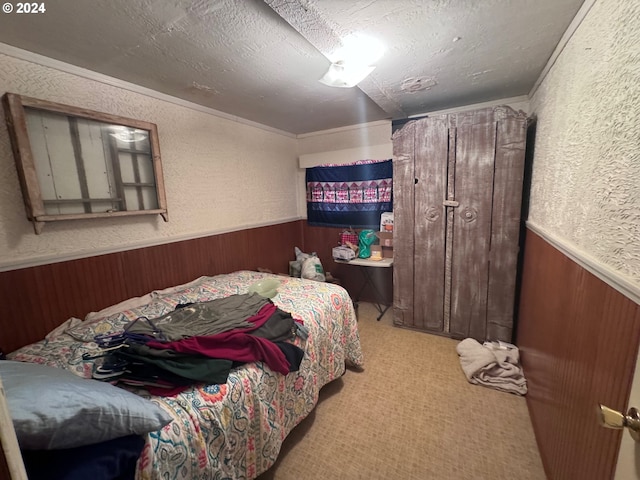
[449,109,496,341]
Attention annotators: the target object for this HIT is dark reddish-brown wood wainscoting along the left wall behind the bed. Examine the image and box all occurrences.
[0,220,303,353]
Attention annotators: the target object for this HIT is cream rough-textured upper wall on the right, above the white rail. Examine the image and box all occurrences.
[529,0,640,287]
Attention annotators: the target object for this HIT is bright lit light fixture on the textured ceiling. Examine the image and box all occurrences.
[320,34,385,88]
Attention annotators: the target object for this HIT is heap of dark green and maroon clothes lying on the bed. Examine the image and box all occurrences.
[86,293,308,395]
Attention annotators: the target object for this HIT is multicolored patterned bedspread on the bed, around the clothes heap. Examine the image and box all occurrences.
[3,271,363,480]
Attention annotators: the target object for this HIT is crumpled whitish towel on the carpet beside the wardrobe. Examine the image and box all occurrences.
[456,338,527,395]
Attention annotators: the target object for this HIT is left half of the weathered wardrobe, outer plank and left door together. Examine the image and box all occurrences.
[393,116,449,332]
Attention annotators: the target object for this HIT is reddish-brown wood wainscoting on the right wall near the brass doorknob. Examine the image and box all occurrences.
[517,230,640,480]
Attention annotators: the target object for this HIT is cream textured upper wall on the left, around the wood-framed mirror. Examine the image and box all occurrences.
[0,54,299,268]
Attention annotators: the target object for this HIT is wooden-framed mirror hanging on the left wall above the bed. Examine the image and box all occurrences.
[3,93,168,234]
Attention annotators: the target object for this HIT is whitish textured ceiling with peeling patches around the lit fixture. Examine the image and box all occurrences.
[0,0,583,133]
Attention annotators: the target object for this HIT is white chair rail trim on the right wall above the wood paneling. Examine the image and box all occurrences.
[527,221,640,305]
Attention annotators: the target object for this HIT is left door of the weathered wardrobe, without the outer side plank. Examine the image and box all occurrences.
[413,116,449,332]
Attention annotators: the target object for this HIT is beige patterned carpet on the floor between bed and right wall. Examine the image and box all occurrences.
[259,303,545,480]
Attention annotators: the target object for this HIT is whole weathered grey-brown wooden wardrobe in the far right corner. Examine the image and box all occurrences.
[393,107,527,342]
